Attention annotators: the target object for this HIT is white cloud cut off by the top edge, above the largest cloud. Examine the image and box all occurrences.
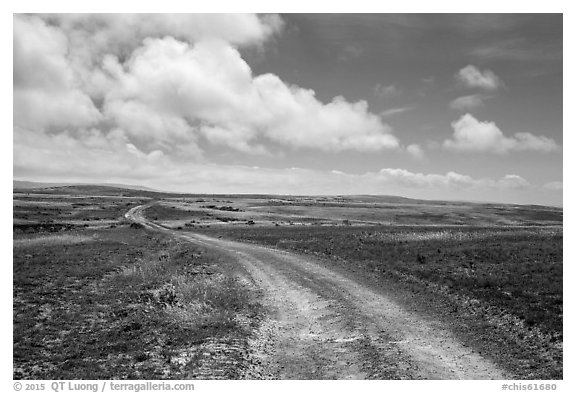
[41,14,284,96]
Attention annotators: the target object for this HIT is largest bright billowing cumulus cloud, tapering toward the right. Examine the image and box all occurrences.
[100,38,399,151]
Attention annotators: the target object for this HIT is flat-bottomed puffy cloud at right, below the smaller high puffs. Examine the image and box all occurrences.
[443,113,558,154]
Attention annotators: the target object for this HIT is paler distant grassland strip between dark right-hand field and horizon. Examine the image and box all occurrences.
[137,195,563,227]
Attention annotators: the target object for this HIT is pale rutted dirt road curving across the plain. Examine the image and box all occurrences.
[126,205,509,379]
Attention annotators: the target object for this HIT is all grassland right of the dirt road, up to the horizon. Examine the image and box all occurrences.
[137,196,563,379]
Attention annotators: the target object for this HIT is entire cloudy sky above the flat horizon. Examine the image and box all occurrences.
[13,14,563,205]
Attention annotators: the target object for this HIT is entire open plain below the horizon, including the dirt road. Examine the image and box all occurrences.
[13,186,563,379]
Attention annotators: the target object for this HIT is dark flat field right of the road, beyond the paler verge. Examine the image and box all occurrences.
[200,227,562,337]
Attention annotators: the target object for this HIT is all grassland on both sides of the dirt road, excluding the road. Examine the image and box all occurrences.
[13,187,563,379]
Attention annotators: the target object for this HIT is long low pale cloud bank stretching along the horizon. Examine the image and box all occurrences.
[14,129,530,197]
